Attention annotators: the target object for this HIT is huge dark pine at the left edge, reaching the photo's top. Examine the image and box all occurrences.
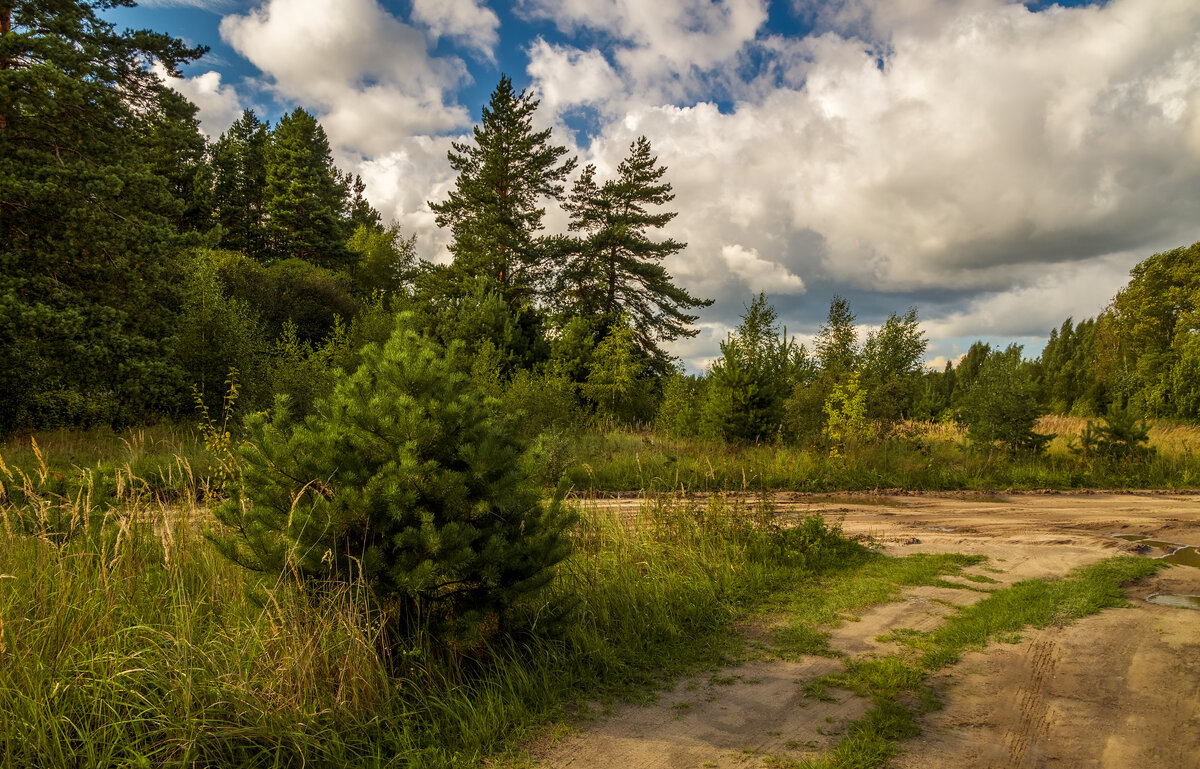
[0,0,203,431]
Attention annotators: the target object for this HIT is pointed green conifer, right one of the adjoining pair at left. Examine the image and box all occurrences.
[265,107,353,271]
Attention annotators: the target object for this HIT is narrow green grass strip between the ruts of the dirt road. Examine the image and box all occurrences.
[794,555,1164,769]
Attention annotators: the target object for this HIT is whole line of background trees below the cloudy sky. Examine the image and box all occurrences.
[0,0,1200,450]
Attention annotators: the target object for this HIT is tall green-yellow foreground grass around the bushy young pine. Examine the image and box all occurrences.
[0,457,862,768]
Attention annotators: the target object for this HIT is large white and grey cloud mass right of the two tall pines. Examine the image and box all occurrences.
[529,0,1200,364]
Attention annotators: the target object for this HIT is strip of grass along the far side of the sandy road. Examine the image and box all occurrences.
[9,417,1200,499]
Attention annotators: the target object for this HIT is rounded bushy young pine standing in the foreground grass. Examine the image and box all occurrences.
[212,314,570,644]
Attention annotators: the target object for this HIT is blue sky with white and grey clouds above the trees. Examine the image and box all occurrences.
[108,0,1200,371]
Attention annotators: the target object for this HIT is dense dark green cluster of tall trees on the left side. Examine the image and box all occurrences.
[0,0,378,432]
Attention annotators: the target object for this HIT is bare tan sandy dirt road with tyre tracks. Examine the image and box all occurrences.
[534,493,1200,769]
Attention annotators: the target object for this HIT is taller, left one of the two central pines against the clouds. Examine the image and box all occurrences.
[430,77,575,306]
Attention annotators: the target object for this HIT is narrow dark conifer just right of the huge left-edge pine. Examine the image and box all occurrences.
[212,109,270,262]
